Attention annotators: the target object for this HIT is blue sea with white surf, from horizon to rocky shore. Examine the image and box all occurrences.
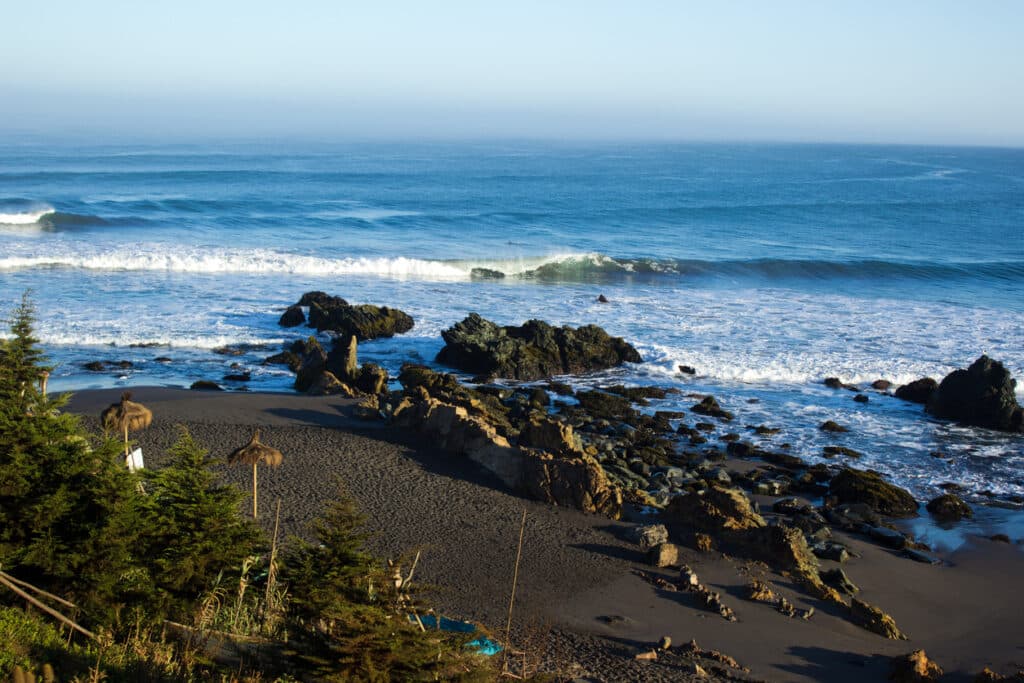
[0,140,1024,518]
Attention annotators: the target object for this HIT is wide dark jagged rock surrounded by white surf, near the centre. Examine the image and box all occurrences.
[437,313,642,380]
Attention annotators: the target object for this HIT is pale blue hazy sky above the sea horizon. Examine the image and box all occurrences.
[0,0,1024,145]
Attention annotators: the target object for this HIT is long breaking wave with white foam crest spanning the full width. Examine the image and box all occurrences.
[0,246,1024,283]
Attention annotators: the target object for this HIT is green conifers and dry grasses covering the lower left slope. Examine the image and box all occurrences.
[0,296,494,681]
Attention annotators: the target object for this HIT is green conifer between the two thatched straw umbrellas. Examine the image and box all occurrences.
[136,427,263,616]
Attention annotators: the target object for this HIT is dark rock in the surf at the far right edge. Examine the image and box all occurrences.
[926,355,1024,432]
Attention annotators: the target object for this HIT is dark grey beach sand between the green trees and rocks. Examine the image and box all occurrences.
[69,387,1024,681]
